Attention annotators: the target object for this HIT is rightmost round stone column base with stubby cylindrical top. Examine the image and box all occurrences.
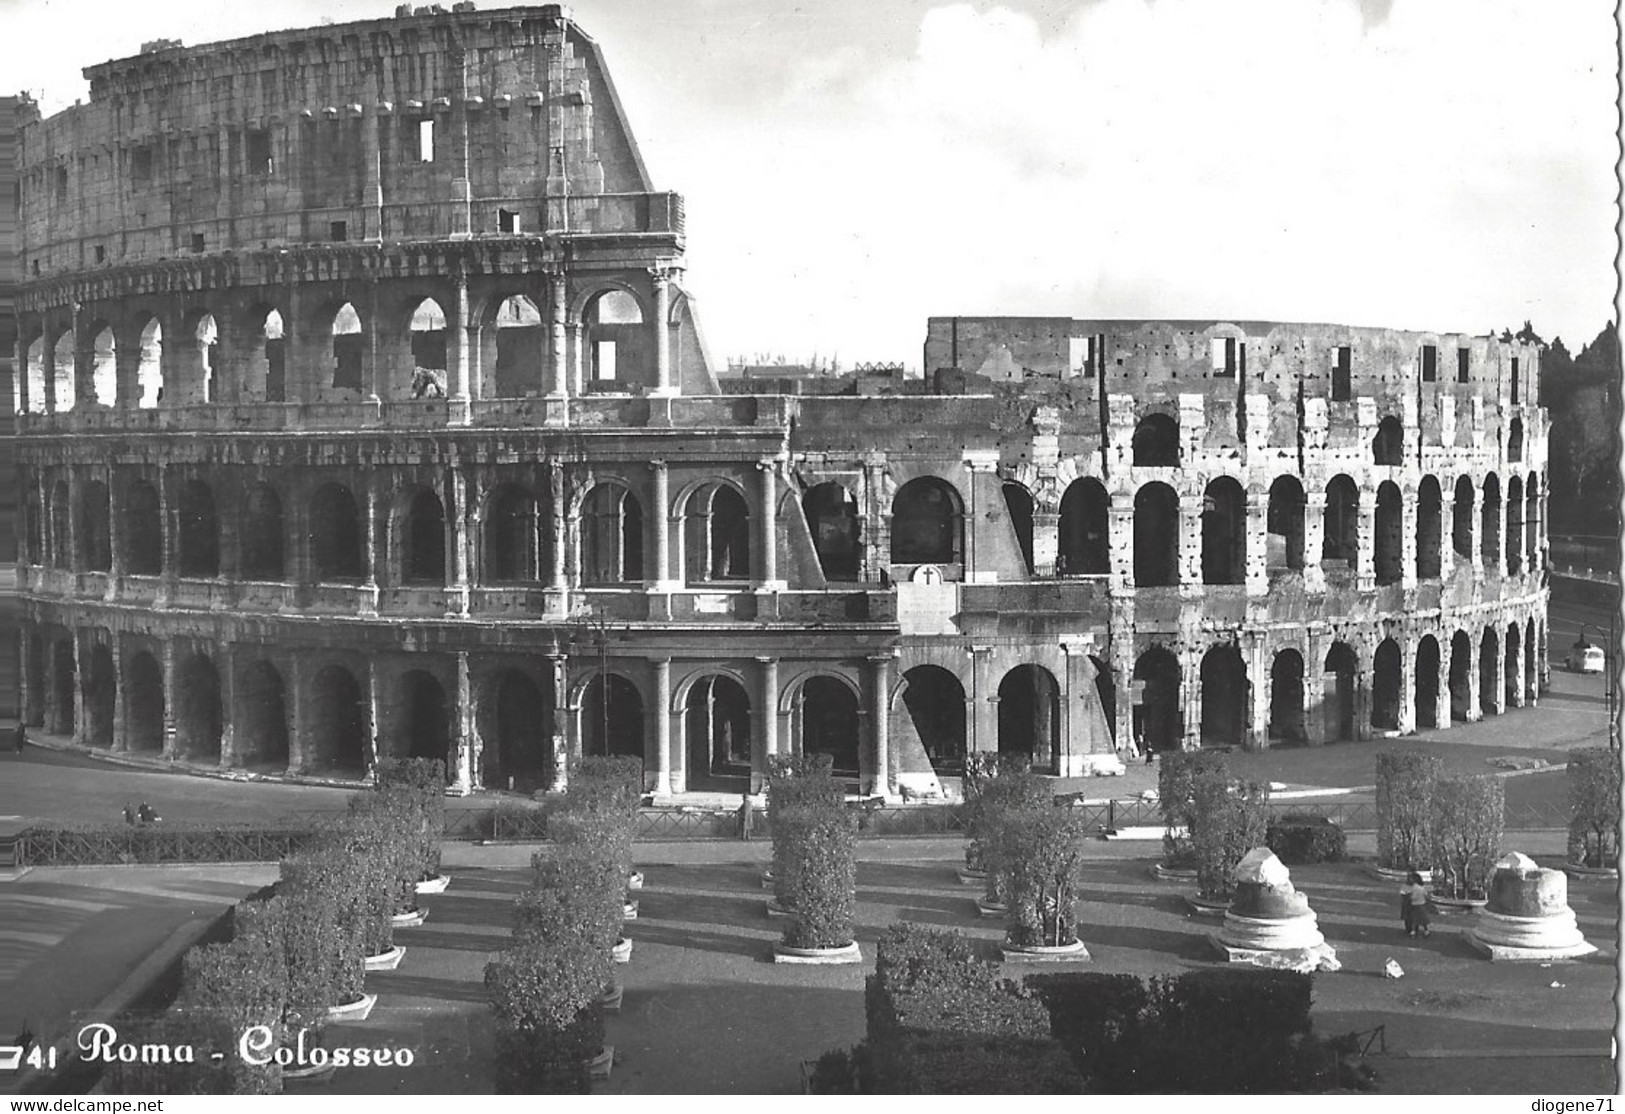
[1467,851,1597,961]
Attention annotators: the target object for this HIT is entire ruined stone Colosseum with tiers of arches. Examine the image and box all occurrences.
[16,3,1547,799]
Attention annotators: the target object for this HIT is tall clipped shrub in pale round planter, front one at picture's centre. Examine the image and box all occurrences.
[774,805,858,948]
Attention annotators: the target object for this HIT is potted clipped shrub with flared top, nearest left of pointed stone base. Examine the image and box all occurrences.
[991,805,1089,947]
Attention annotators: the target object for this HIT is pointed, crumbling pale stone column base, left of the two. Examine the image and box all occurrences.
[1209,848,1339,971]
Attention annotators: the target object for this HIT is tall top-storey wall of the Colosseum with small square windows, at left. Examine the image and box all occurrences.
[21,5,663,279]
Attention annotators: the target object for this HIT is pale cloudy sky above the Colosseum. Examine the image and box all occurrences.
[0,0,1620,367]
